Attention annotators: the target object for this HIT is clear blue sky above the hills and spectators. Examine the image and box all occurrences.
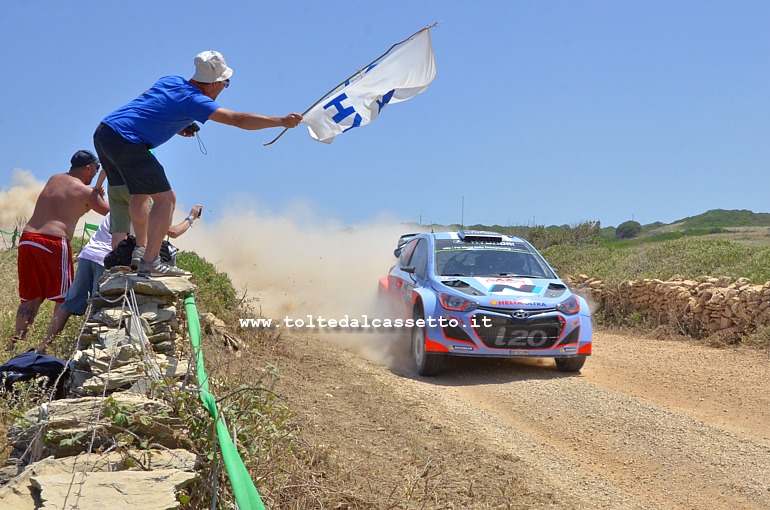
[0,0,770,226]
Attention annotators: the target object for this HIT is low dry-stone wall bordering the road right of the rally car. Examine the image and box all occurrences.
[565,274,770,338]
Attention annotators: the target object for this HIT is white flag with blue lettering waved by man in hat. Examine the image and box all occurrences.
[302,28,436,143]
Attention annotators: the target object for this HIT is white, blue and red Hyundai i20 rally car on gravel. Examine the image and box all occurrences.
[378,231,592,376]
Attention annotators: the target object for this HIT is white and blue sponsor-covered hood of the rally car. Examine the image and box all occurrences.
[436,276,570,305]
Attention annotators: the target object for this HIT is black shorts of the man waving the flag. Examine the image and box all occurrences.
[94,122,171,195]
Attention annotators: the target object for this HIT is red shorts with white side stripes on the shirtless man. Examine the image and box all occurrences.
[18,232,74,303]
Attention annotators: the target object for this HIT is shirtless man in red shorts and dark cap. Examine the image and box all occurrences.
[8,150,110,352]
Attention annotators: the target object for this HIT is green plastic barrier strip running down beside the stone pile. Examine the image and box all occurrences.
[184,294,265,510]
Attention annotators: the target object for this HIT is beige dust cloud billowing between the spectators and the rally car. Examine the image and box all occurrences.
[177,204,424,368]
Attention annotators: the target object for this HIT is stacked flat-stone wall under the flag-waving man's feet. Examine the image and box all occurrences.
[0,268,197,510]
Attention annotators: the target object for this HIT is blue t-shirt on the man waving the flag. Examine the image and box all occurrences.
[102,76,220,148]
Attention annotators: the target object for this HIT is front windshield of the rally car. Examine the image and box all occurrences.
[434,243,555,278]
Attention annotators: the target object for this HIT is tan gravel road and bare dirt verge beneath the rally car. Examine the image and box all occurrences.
[280,333,770,509]
